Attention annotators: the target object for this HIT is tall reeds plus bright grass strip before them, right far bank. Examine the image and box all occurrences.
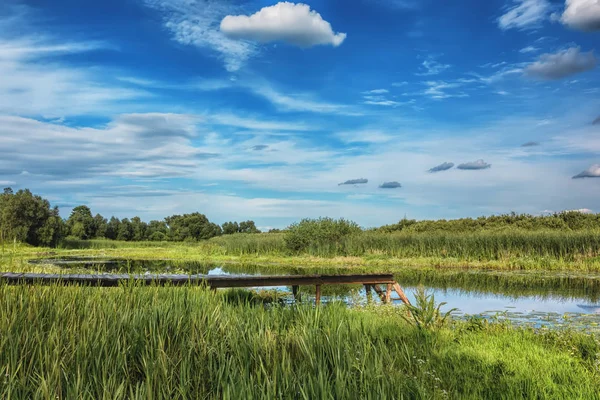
[205,230,600,271]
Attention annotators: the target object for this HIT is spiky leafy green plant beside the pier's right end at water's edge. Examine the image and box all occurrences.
[402,286,458,330]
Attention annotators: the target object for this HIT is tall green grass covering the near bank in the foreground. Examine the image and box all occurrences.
[0,286,600,399]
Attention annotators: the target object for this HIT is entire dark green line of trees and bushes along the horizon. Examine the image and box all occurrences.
[0,188,600,249]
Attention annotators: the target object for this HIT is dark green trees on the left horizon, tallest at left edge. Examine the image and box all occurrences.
[0,188,260,246]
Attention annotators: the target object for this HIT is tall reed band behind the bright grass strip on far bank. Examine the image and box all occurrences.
[210,230,600,260]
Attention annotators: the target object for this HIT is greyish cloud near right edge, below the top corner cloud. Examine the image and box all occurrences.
[525,47,597,80]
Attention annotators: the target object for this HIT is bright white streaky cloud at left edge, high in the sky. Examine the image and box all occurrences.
[0,33,152,118]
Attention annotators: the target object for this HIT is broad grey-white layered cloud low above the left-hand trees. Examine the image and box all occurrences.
[0,113,218,180]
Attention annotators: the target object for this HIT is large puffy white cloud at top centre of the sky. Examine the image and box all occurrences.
[221,1,346,47]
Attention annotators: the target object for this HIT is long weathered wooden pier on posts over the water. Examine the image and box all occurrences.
[0,273,410,304]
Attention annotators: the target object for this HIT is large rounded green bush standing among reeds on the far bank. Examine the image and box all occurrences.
[284,218,362,255]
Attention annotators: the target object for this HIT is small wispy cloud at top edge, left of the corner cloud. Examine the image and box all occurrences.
[498,0,551,30]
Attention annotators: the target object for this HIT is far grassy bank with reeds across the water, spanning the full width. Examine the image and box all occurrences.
[8,230,600,272]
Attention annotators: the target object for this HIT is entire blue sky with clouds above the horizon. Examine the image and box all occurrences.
[0,0,600,228]
